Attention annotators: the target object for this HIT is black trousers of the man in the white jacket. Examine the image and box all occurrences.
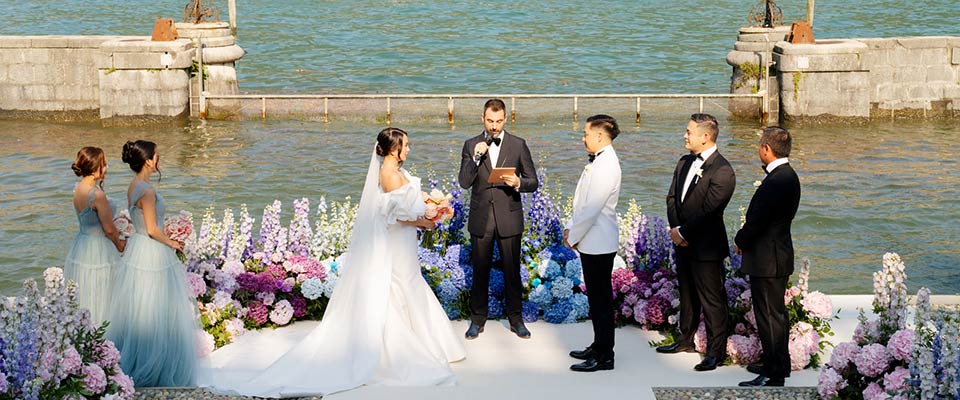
[580,253,617,360]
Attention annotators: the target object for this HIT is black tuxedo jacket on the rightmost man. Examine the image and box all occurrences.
[734,163,800,278]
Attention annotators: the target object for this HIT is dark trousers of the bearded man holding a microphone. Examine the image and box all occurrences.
[470,207,523,325]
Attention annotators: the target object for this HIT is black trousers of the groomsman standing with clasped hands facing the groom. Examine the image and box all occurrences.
[677,252,730,359]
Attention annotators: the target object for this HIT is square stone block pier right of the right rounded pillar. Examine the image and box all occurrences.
[773,39,871,121]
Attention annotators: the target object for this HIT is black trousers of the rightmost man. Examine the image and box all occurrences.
[750,276,790,378]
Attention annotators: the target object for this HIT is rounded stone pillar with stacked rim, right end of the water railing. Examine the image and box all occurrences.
[727,26,790,118]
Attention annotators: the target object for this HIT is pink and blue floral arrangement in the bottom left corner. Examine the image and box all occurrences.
[0,268,134,400]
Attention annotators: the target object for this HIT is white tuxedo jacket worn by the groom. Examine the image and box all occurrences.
[565,145,620,254]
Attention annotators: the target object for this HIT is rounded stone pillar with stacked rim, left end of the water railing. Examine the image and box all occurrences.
[176,22,247,119]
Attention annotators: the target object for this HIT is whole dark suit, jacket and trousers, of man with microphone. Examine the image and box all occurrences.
[458,131,540,326]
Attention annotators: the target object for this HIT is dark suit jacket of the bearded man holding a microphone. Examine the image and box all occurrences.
[458,131,540,237]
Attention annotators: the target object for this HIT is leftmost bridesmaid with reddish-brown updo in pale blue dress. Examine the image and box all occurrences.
[63,147,126,326]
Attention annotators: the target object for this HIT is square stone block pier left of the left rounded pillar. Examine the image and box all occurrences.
[97,37,194,125]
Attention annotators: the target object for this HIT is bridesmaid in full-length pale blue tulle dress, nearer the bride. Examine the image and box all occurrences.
[107,140,200,387]
